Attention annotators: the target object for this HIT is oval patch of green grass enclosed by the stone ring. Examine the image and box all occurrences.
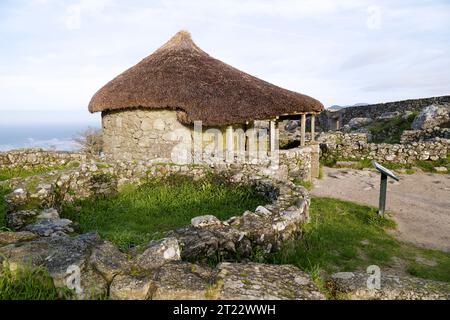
[61,175,267,250]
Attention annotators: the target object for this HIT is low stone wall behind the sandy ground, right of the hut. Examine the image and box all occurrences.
[320,132,450,164]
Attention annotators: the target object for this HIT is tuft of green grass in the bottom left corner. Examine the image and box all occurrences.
[0,261,70,300]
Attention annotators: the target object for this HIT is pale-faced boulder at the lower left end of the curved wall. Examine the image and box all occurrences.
[136,237,181,270]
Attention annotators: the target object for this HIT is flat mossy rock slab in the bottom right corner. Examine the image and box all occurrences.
[332,272,450,300]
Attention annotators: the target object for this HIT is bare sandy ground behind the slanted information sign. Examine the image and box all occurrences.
[312,168,450,252]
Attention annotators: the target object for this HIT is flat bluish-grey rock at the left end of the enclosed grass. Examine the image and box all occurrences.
[23,219,79,237]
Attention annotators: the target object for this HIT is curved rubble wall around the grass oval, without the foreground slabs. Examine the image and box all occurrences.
[6,158,309,258]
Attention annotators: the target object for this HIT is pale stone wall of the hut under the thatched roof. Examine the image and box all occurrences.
[102,109,251,164]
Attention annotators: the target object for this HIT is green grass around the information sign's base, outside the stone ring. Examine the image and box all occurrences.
[269,198,450,282]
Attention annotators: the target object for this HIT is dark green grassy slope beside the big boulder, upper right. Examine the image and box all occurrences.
[367,113,417,143]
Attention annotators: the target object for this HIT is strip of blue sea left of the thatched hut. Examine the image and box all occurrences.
[0,124,100,151]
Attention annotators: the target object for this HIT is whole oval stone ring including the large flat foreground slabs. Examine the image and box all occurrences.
[0,158,316,299]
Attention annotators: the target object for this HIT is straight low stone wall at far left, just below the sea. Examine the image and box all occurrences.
[0,149,88,168]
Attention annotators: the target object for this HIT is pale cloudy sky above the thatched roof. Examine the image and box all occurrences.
[0,0,450,126]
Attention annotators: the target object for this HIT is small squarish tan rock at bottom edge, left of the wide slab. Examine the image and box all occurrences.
[109,275,154,300]
